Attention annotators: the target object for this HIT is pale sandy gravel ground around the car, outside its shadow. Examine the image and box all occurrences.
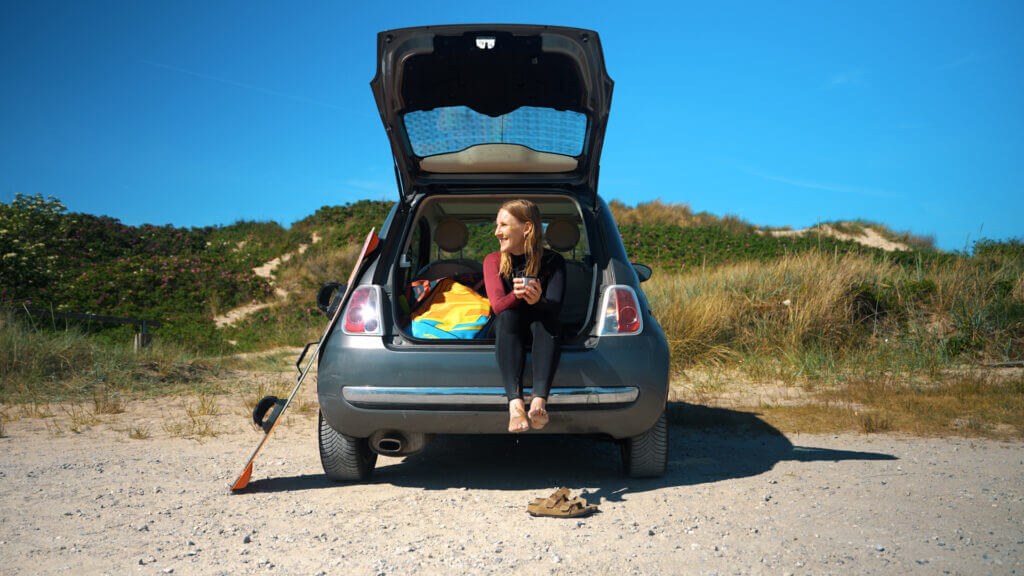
[0,384,1024,575]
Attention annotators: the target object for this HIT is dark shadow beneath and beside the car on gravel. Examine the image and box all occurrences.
[241,403,897,501]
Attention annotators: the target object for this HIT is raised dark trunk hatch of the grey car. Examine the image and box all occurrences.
[371,25,612,200]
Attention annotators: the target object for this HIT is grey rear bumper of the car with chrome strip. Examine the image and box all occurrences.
[317,322,669,438]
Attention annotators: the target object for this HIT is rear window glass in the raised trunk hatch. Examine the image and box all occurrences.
[402,106,587,158]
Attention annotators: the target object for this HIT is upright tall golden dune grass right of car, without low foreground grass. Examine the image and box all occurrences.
[644,248,1024,374]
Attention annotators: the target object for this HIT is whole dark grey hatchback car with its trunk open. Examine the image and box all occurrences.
[317,25,669,481]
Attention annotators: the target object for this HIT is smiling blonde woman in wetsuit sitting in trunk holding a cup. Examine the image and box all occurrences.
[483,200,565,433]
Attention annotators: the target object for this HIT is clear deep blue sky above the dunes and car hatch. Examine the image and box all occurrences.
[0,1,1024,249]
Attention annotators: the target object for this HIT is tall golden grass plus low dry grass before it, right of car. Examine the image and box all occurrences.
[644,252,1024,435]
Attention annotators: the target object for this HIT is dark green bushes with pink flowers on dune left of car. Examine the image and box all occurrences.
[0,195,276,351]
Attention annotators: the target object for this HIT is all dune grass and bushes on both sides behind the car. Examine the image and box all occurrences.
[0,196,1024,436]
